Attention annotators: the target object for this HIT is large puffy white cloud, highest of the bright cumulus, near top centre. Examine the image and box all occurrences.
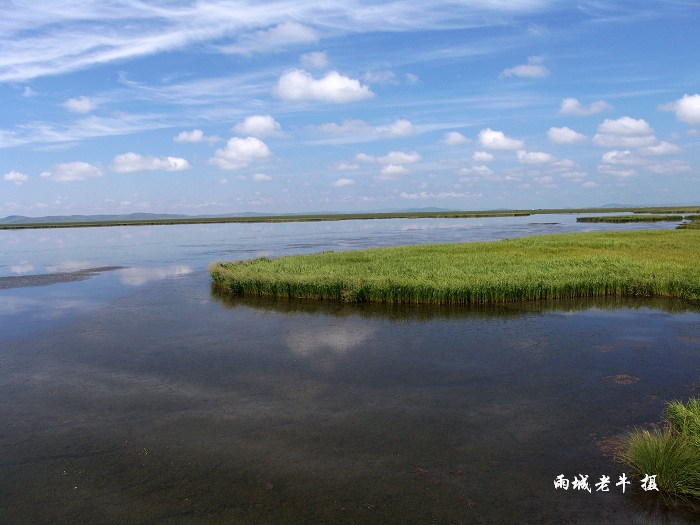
[272,69,374,103]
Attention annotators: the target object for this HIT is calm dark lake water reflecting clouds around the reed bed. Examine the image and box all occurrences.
[0,215,700,524]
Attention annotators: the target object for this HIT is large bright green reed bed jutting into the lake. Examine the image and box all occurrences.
[209,230,700,304]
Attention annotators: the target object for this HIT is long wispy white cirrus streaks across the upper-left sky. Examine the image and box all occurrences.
[0,0,553,82]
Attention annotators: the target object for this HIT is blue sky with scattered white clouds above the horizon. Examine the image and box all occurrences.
[0,0,700,217]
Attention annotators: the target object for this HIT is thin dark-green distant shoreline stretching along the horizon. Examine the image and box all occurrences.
[0,206,700,230]
